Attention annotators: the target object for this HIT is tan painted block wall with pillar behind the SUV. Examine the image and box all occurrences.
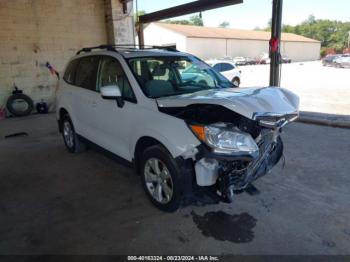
[0,0,135,109]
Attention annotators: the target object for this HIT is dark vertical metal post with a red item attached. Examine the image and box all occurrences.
[270,0,283,86]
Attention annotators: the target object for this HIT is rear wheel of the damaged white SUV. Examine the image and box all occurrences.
[61,114,86,153]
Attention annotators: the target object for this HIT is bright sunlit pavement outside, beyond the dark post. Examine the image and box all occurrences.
[241,61,350,115]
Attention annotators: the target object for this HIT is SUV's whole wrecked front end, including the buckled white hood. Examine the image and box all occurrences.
[157,87,299,202]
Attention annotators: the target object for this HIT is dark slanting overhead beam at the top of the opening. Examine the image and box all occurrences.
[139,0,243,24]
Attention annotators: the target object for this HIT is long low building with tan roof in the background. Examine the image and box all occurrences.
[144,23,321,61]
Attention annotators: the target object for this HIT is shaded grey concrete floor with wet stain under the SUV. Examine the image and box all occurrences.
[0,115,350,254]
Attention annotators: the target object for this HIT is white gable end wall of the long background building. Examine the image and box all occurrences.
[143,24,186,52]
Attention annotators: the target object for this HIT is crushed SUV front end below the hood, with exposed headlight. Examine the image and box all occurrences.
[162,105,298,202]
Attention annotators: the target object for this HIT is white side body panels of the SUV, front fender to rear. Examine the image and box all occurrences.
[57,51,200,162]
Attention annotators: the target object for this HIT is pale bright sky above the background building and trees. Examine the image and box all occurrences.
[135,0,350,29]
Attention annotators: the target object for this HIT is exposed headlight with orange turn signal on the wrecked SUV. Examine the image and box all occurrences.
[190,123,259,154]
